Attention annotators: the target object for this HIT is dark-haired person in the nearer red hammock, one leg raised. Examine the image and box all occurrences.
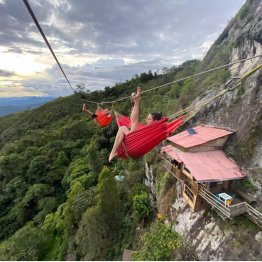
[108,87,162,162]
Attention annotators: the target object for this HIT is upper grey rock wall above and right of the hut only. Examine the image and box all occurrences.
[193,0,262,208]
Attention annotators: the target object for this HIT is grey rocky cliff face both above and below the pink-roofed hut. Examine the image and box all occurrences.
[149,0,262,260]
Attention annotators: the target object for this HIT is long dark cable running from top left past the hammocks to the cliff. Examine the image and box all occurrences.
[23,0,262,106]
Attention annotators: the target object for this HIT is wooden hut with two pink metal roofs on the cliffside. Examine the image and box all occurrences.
[161,125,246,211]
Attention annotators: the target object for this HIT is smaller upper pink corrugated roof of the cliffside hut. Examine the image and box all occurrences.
[167,126,233,148]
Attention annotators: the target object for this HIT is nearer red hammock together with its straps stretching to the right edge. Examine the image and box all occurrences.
[110,65,262,159]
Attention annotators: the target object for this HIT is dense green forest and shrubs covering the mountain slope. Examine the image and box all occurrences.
[0,2,262,260]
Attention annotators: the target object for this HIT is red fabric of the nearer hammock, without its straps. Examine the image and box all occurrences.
[116,115,185,159]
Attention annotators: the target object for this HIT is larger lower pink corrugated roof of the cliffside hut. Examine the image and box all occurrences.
[162,145,246,182]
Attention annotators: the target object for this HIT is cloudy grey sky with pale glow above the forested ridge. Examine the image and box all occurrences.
[0,0,245,98]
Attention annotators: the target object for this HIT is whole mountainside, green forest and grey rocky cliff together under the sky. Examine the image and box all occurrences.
[0,0,262,260]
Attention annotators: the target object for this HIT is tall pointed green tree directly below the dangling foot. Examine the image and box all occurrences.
[76,167,122,260]
